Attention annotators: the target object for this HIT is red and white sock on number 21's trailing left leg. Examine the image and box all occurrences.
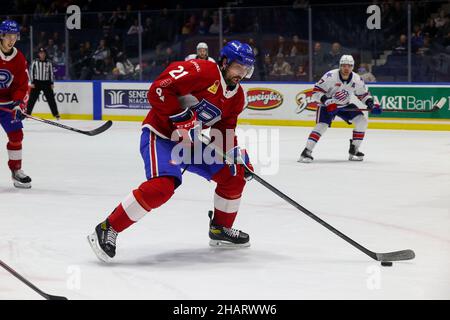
[108,177,175,232]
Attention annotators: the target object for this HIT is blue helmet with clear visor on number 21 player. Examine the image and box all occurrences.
[219,40,255,78]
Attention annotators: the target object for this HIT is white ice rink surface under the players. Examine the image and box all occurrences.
[0,120,450,300]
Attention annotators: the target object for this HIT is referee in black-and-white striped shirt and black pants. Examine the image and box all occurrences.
[27,48,60,120]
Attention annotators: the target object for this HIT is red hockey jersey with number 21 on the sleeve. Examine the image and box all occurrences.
[143,59,246,150]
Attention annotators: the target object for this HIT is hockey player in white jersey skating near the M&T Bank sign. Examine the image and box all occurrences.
[298,55,382,162]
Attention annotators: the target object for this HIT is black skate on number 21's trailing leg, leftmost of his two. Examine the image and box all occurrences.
[88,219,118,262]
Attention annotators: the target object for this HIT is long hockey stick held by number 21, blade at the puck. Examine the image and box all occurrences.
[200,134,415,262]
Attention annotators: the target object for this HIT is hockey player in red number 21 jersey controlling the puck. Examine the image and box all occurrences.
[88,41,255,261]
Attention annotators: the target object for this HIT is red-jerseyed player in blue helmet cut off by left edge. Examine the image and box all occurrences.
[0,20,31,188]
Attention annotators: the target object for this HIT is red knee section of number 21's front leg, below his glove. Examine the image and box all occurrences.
[213,166,246,199]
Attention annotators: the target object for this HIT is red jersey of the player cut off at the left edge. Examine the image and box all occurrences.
[0,48,28,105]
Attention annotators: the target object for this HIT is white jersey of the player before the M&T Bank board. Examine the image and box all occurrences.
[313,69,373,107]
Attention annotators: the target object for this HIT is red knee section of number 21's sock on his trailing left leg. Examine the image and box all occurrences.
[139,177,175,211]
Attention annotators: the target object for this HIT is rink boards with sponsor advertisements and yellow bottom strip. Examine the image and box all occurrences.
[35,81,450,130]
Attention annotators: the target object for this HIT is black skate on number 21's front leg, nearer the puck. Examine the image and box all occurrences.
[208,211,250,248]
